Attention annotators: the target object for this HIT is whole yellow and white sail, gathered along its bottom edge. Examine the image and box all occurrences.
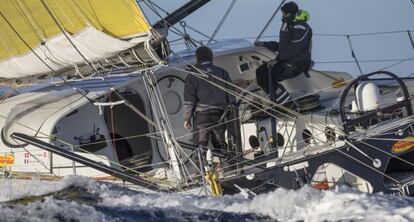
[0,0,166,83]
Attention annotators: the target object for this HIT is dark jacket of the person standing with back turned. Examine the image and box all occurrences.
[184,62,235,121]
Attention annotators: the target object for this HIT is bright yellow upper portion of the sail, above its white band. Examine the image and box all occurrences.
[0,0,150,59]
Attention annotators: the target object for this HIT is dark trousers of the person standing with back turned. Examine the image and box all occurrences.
[194,110,226,151]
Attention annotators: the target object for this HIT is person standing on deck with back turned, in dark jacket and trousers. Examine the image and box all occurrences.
[184,46,234,152]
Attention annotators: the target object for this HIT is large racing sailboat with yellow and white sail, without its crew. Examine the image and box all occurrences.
[0,0,414,195]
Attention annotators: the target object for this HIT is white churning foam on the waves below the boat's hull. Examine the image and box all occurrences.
[0,177,414,222]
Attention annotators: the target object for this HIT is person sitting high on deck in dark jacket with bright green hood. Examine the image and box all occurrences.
[255,2,312,103]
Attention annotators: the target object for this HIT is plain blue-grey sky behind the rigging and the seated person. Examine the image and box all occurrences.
[143,0,414,76]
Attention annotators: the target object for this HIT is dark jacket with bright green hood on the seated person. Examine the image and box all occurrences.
[277,10,312,66]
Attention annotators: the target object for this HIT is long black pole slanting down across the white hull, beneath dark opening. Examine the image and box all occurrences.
[11,133,171,192]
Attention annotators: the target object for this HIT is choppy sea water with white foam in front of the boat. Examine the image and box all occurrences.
[0,176,414,222]
